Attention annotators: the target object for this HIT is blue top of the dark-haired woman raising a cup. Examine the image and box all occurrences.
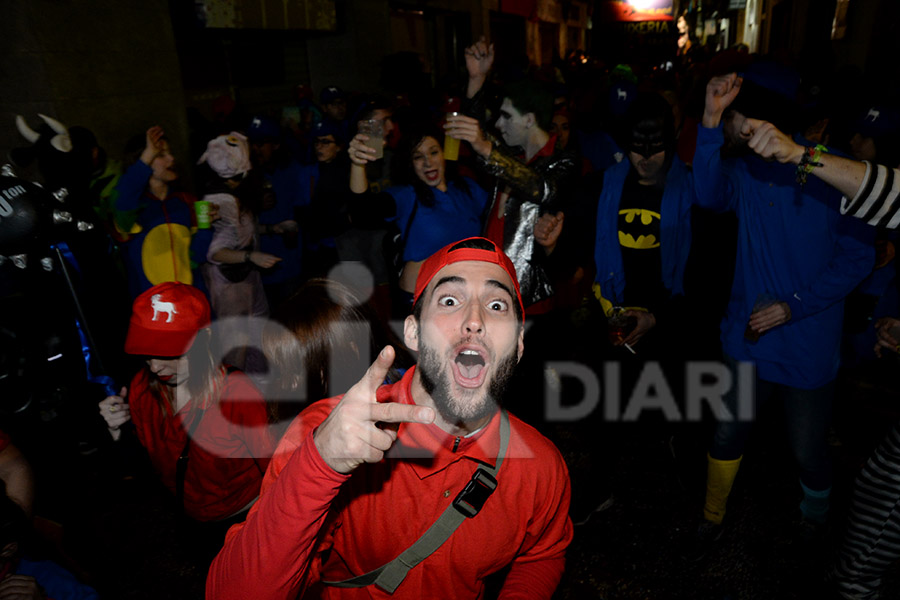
[387,178,487,261]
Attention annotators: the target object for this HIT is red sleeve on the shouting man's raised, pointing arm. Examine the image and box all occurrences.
[206,408,349,600]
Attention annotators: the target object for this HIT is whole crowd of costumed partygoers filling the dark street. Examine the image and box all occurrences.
[0,28,900,599]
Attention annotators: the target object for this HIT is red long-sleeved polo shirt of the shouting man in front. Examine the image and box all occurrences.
[206,369,572,600]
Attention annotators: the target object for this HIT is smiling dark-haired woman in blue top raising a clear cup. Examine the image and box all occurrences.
[349,121,487,314]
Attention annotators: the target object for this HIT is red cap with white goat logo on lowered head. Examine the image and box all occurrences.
[125,281,210,356]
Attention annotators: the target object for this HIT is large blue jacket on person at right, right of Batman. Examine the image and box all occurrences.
[694,125,875,389]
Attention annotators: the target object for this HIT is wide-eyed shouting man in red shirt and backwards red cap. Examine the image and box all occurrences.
[206,238,572,599]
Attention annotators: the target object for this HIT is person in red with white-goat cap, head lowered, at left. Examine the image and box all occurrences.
[99,282,275,556]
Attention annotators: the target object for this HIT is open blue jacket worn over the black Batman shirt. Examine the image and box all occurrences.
[594,156,694,304]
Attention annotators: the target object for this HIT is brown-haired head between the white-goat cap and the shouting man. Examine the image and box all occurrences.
[263,279,413,427]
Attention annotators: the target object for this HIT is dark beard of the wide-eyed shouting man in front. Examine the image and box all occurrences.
[416,344,518,426]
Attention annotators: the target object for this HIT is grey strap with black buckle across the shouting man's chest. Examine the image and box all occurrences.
[322,409,510,594]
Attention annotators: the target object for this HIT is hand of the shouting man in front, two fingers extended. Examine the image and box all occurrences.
[313,346,434,473]
